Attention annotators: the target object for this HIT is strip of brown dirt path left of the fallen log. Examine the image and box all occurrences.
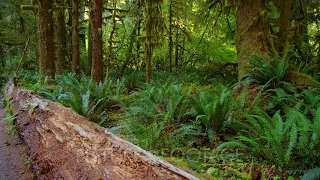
[0,100,34,180]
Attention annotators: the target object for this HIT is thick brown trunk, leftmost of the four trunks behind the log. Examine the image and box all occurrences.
[39,0,54,83]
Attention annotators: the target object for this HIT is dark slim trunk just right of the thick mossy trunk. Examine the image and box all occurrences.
[278,0,291,54]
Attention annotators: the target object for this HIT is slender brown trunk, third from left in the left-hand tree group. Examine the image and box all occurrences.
[72,0,80,74]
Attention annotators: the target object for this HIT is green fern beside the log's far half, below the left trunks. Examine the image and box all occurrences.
[57,74,125,117]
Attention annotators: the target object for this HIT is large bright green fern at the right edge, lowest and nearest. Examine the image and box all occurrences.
[217,107,320,168]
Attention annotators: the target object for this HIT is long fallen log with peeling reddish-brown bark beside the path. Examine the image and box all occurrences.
[5,83,197,180]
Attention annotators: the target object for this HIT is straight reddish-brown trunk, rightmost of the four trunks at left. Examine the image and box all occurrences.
[91,0,103,82]
